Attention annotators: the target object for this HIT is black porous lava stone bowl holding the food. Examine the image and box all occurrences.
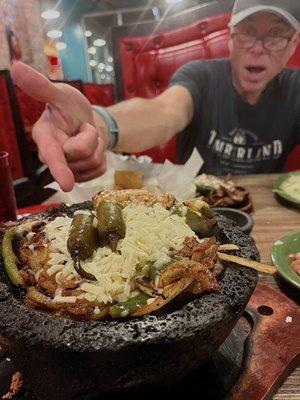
[0,206,259,400]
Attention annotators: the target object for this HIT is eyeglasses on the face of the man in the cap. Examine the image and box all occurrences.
[231,32,292,51]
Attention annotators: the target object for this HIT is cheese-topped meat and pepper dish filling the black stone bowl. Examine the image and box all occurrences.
[2,190,275,320]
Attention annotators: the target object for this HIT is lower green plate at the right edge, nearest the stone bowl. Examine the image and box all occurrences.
[271,231,300,289]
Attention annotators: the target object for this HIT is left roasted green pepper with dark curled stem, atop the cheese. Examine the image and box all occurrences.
[67,212,98,281]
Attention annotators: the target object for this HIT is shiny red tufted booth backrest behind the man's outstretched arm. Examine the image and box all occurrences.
[120,13,230,162]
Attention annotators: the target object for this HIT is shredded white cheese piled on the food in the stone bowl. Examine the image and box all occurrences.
[46,204,196,303]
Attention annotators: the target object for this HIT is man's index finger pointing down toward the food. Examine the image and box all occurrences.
[32,118,75,192]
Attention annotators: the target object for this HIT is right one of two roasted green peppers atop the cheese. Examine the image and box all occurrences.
[97,201,126,251]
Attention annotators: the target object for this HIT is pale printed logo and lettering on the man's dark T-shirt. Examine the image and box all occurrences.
[208,128,282,164]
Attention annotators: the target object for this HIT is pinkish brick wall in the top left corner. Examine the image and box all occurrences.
[0,0,47,74]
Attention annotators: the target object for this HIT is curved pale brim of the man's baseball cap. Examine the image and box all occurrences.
[229,6,300,31]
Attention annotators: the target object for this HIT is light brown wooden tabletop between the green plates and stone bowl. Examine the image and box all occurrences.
[234,174,300,400]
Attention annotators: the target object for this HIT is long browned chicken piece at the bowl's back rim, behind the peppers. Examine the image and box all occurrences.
[93,189,176,209]
